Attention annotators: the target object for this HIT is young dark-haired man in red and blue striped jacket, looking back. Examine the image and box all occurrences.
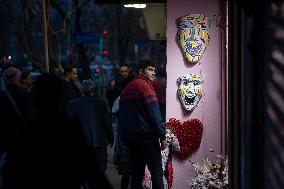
[119,60,165,189]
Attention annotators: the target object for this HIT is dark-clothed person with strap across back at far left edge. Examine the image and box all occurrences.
[0,67,32,187]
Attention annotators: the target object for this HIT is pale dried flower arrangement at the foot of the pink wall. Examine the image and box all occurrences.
[190,155,229,189]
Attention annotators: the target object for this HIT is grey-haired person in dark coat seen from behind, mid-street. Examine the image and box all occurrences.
[68,80,114,172]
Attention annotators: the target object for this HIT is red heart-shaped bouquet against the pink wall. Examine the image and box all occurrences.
[167,118,203,160]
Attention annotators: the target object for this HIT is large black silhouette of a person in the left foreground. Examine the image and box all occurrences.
[4,74,111,189]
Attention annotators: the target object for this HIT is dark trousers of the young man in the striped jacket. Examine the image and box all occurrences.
[125,138,164,189]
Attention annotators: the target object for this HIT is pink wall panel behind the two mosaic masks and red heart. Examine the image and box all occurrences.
[166,0,226,189]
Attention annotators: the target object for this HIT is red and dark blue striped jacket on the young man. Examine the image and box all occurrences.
[119,75,165,140]
